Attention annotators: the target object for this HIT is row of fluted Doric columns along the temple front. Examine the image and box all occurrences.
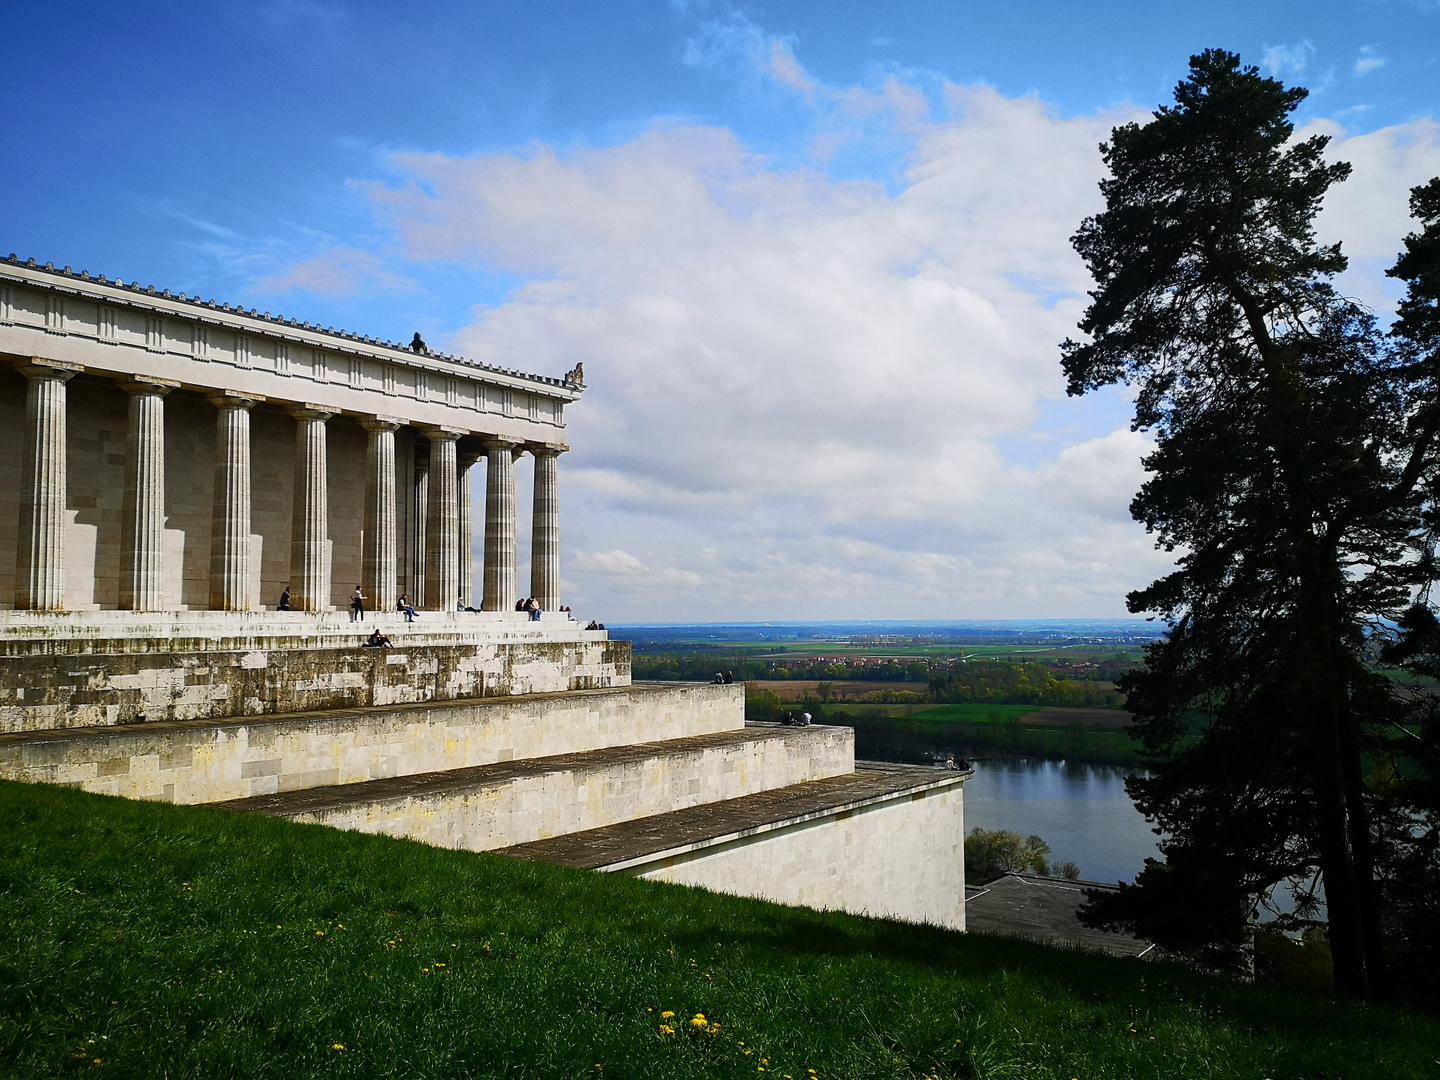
[16,360,562,611]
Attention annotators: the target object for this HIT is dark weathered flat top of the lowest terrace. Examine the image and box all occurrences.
[494,766,973,874]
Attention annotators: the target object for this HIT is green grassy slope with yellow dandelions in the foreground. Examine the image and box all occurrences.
[0,783,1440,1080]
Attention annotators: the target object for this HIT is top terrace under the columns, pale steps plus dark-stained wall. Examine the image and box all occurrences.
[0,612,631,732]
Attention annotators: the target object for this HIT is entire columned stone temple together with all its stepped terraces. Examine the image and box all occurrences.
[0,256,969,929]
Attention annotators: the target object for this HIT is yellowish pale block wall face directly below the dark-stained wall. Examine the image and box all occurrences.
[0,684,744,804]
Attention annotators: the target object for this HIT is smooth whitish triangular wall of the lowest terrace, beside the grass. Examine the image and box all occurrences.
[633,783,965,930]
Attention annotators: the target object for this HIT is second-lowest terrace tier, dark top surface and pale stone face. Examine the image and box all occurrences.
[208,726,855,851]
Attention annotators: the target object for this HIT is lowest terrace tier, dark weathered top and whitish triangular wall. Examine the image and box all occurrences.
[497,762,969,930]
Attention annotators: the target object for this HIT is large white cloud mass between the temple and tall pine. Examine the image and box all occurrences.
[362,39,1436,621]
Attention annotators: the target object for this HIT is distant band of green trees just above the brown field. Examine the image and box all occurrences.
[631,652,1130,708]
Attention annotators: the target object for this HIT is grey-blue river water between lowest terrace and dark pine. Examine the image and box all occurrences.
[965,760,1159,881]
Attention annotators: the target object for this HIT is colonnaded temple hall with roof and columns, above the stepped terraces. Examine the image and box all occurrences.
[0,255,583,612]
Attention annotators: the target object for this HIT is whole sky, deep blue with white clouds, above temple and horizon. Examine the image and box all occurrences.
[0,0,1440,619]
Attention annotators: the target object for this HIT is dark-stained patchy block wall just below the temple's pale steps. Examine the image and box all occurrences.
[0,635,629,732]
